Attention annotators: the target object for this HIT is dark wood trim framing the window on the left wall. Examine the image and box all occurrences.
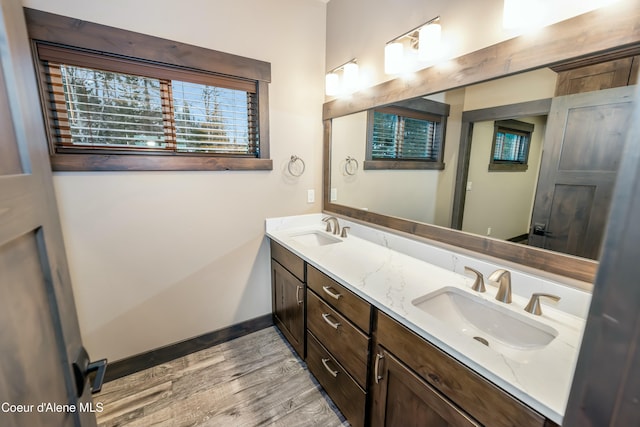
[24,8,273,171]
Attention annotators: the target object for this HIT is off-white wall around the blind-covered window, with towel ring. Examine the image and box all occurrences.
[23,0,326,361]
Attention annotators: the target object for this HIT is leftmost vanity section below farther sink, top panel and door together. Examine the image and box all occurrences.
[271,241,305,358]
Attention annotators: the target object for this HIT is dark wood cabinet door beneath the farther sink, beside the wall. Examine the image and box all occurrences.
[271,261,305,359]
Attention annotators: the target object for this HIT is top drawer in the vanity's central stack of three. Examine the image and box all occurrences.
[307,266,371,334]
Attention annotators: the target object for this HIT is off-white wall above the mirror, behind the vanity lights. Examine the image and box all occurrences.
[325,0,636,87]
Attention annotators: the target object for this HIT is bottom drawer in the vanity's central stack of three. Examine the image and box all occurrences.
[307,333,366,427]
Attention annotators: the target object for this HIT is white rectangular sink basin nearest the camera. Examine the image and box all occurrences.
[411,287,558,362]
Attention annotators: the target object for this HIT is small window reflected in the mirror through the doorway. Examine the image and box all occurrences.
[489,120,534,172]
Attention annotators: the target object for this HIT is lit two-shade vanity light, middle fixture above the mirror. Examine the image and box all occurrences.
[384,16,442,74]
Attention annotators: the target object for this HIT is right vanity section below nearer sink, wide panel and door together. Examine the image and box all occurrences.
[371,312,553,427]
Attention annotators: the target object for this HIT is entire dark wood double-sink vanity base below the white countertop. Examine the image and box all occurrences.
[271,241,556,427]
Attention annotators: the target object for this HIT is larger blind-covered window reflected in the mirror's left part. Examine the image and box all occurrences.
[364,99,449,169]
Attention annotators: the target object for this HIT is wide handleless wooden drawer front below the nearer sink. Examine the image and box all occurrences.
[377,313,545,427]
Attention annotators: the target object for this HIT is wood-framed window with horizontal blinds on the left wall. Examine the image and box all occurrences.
[27,9,272,170]
